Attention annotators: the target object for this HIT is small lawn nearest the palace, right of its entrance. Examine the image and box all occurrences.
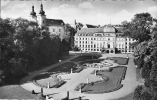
[107,57,129,65]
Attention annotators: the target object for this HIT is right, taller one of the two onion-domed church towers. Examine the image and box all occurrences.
[37,3,46,27]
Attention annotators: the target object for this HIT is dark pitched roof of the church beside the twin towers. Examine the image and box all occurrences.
[45,19,65,26]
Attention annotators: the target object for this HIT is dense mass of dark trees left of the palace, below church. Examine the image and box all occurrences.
[0,18,75,83]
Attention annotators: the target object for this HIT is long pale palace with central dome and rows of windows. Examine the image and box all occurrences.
[74,25,135,53]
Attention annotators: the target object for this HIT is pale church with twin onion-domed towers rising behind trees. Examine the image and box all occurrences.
[29,3,65,35]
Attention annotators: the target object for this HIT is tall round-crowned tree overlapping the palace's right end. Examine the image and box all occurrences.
[122,13,153,43]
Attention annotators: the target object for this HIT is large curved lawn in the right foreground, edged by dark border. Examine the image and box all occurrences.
[82,66,126,93]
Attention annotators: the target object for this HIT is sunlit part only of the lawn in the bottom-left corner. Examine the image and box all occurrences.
[0,85,39,99]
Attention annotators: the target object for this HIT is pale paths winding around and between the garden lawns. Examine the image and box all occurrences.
[20,54,142,100]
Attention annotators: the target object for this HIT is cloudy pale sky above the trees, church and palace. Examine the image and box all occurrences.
[1,0,157,25]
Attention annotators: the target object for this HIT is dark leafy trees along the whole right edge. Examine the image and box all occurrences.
[123,13,157,100]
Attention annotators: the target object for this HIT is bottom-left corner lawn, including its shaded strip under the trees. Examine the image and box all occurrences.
[0,73,39,99]
